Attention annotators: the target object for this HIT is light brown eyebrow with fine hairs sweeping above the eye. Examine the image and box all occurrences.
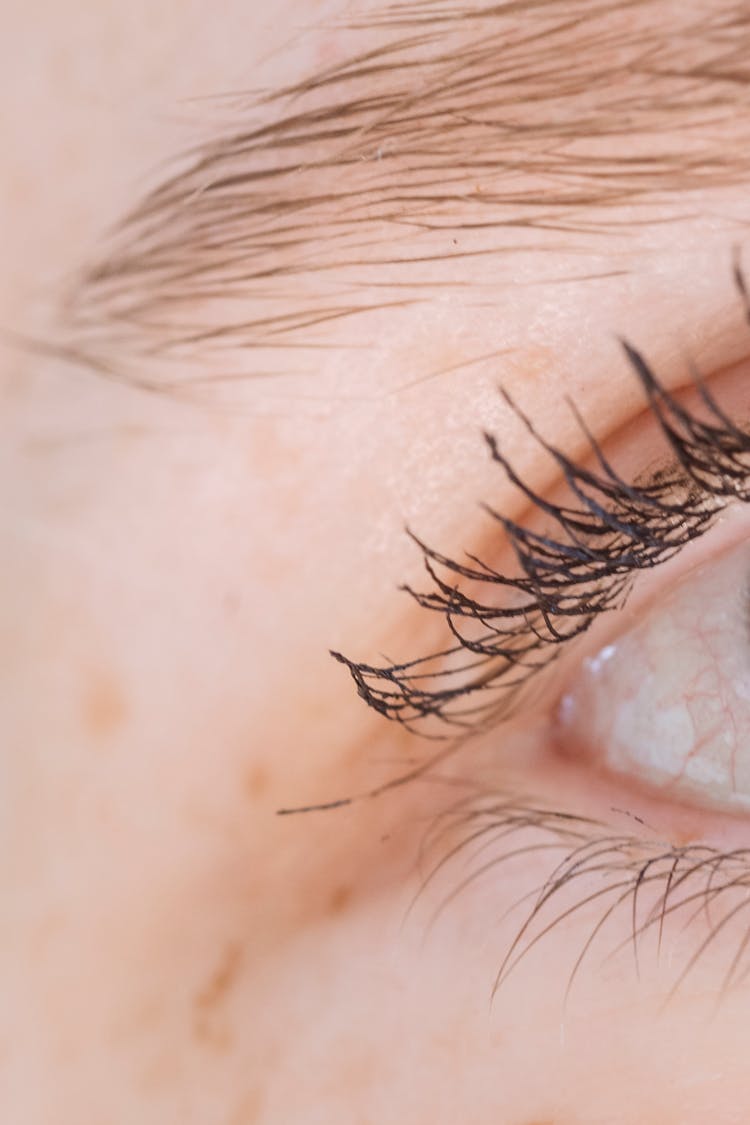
[58,0,750,387]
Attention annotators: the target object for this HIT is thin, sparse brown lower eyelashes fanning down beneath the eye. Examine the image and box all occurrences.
[419,795,750,1004]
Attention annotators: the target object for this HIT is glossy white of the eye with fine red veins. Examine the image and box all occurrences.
[558,542,750,808]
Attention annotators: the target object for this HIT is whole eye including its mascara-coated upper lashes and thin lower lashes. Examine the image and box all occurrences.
[335,263,750,1003]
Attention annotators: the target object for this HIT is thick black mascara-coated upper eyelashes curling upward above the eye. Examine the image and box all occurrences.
[332,267,750,738]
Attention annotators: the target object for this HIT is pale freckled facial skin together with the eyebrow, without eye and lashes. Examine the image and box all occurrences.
[0,0,750,1125]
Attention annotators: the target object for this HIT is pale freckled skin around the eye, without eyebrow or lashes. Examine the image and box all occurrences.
[7,0,750,1125]
